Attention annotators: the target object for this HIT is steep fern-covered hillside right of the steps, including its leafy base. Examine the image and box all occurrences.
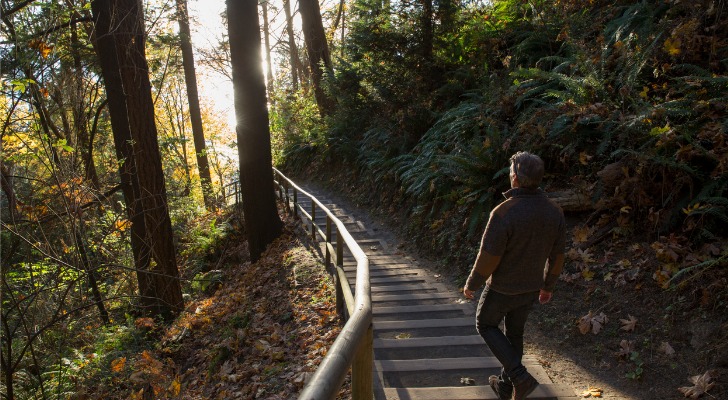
[280,1,728,398]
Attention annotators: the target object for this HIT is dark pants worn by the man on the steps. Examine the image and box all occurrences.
[475,287,538,384]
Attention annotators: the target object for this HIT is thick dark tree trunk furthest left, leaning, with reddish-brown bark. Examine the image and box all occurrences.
[91,0,183,318]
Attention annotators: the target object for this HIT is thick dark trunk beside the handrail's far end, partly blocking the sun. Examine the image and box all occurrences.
[226,0,283,261]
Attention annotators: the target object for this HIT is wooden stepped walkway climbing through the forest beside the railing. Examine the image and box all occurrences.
[298,187,577,400]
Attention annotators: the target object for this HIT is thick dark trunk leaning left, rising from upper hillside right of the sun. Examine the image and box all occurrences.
[299,0,334,116]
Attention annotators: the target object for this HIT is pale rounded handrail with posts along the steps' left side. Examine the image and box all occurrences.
[273,168,374,400]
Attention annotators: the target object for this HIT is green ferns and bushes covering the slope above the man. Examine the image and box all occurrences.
[276,0,728,270]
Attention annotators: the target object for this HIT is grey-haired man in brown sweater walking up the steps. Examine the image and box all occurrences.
[463,152,566,400]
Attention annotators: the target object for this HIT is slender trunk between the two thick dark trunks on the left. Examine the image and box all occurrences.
[176,0,215,210]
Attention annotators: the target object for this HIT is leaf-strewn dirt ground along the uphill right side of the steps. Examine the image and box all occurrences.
[300,179,728,400]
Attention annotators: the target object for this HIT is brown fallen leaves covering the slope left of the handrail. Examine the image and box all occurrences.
[96,222,350,399]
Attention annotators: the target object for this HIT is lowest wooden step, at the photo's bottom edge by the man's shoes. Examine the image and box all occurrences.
[384,383,577,400]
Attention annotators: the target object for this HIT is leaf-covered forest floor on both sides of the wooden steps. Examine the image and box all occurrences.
[88,185,728,400]
